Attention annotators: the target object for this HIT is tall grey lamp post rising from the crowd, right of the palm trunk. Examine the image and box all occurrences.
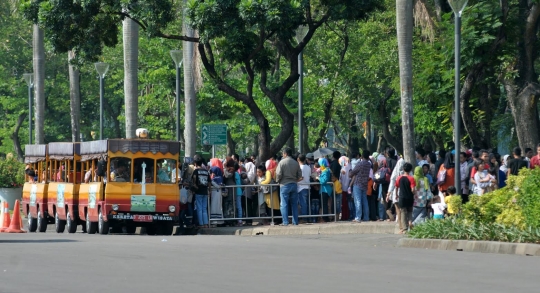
[448,0,469,195]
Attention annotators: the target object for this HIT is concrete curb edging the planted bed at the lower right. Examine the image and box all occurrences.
[397,238,540,256]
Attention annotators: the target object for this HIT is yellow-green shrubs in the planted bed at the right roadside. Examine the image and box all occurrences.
[409,168,540,243]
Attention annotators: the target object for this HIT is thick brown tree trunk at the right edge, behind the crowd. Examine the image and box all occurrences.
[504,80,540,150]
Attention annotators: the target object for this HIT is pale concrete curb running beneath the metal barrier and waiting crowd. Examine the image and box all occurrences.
[199,223,399,236]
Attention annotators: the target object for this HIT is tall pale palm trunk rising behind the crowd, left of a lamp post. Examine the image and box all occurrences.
[396,0,416,166]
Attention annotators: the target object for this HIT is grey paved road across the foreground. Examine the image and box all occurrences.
[0,233,540,293]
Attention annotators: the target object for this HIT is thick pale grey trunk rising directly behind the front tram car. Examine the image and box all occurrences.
[123,18,139,139]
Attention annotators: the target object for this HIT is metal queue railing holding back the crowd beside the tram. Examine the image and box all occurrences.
[188,182,341,227]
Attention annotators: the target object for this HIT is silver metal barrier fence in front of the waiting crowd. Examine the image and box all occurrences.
[187,182,341,227]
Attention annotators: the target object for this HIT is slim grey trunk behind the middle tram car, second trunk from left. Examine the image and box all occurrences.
[68,51,81,142]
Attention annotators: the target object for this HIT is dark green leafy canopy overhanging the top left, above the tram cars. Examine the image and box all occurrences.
[22,0,174,62]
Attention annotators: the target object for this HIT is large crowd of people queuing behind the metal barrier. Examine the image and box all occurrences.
[181,144,540,233]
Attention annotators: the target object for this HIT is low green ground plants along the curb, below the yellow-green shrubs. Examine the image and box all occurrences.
[408,217,540,244]
